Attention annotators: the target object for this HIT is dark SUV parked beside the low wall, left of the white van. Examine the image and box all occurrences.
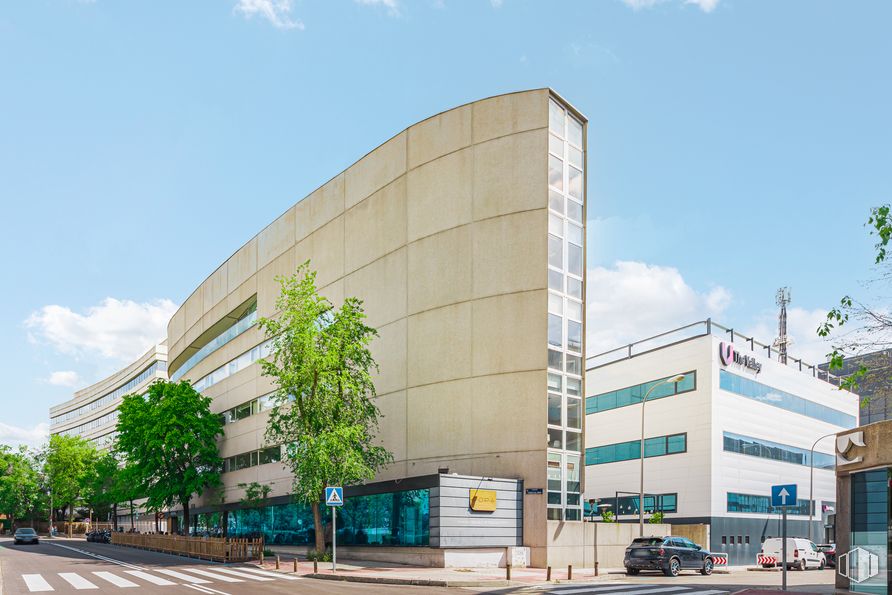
[623,536,714,576]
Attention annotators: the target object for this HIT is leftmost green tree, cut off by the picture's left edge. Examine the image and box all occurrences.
[0,445,42,526]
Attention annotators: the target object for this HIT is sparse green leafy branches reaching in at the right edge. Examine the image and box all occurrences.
[817,204,892,391]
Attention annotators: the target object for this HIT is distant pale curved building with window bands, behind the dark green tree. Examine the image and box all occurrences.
[50,344,167,448]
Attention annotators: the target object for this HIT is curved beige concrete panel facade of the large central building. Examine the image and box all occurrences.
[154,89,585,565]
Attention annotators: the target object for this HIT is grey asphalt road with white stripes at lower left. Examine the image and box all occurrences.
[0,539,454,595]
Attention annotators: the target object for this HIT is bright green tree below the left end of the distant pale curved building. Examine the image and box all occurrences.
[43,434,97,537]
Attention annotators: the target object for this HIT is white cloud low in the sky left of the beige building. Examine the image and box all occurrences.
[25,298,177,362]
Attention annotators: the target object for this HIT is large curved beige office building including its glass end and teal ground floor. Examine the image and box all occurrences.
[168,89,586,565]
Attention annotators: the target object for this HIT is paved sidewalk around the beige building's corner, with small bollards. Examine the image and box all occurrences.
[247,550,625,587]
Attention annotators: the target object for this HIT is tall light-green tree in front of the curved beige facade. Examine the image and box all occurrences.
[258,262,393,551]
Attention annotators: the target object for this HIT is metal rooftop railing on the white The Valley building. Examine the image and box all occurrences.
[585,318,840,386]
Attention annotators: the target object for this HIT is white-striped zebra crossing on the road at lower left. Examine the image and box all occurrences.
[21,566,302,593]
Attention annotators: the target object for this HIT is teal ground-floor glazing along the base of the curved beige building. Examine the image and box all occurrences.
[195,489,430,546]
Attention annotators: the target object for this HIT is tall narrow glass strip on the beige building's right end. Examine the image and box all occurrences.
[546,99,585,521]
